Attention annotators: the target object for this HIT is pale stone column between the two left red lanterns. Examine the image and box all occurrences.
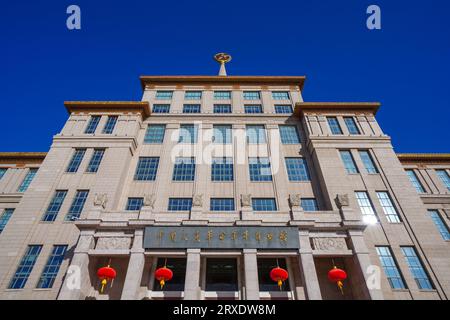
[121,229,145,300]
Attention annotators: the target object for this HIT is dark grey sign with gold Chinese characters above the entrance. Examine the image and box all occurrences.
[144,226,300,249]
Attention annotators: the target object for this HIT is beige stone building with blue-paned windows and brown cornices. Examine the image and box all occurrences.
[0,76,450,300]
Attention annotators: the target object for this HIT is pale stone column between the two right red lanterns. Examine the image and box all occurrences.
[299,231,322,300]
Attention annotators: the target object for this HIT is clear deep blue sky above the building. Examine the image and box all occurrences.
[0,0,450,152]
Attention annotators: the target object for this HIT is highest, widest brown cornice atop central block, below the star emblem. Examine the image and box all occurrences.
[139,76,306,90]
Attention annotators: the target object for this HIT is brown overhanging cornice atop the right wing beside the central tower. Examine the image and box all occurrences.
[294,102,380,117]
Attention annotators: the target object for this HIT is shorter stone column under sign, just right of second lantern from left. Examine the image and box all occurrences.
[184,249,200,300]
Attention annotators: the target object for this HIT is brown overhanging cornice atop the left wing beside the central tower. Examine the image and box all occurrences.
[64,101,150,119]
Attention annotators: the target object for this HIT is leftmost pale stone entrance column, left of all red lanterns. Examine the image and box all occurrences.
[58,230,95,300]
